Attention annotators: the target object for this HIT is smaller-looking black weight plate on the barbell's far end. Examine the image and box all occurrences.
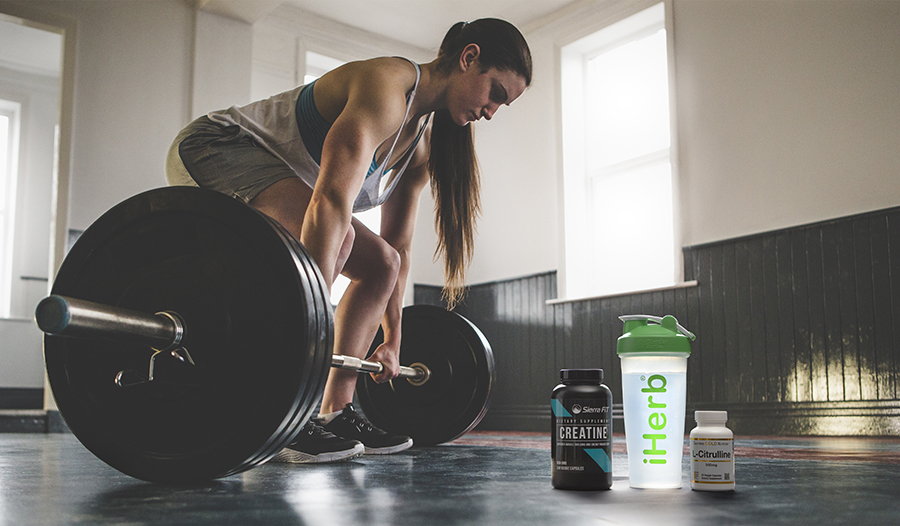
[356,305,495,445]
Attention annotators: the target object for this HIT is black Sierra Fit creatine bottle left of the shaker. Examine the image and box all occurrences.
[550,369,612,490]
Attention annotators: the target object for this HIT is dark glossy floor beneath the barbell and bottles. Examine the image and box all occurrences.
[0,433,900,526]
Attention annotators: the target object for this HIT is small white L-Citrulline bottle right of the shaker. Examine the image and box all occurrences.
[691,411,734,491]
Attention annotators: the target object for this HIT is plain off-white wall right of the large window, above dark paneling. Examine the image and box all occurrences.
[675,0,900,245]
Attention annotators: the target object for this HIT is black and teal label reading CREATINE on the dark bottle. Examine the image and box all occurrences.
[551,399,612,473]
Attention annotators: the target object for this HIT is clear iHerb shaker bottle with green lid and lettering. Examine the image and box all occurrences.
[616,315,694,488]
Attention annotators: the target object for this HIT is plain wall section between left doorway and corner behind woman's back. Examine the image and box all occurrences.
[50,0,194,230]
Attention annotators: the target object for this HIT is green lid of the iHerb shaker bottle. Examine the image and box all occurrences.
[616,314,695,354]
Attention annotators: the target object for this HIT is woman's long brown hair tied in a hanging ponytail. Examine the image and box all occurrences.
[428,18,531,309]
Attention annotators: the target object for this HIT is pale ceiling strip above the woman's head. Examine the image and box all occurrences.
[202,0,582,50]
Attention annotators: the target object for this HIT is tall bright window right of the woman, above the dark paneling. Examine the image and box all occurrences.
[561,4,676,298]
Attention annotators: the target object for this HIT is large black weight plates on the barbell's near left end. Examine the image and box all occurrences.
[45,187,330,482]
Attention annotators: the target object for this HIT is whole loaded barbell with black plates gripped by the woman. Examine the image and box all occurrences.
[35,187,495,483]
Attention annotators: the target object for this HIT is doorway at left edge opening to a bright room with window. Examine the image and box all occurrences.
[0,2,75,409]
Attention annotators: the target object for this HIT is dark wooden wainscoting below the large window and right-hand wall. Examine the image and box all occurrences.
[415,208,900,435]
